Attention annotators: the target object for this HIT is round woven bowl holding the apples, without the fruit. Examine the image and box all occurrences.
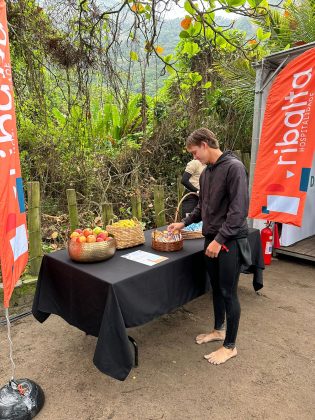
[68,238,116,262]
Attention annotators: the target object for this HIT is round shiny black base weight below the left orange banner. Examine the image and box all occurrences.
[0,379,45,420]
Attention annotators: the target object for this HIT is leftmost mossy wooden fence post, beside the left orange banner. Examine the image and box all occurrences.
[27,181,43,276]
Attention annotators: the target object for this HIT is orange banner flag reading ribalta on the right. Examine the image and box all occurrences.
[249,48,315,226]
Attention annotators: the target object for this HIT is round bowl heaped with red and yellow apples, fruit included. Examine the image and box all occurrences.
[68,227,116,262]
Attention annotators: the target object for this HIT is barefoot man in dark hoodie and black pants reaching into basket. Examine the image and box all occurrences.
[168,128,250,365]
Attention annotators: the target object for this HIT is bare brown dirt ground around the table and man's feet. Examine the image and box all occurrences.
[0,260,315,420]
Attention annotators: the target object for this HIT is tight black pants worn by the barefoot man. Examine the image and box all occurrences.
[205,237,241,349]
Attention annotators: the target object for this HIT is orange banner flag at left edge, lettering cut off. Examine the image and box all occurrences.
[0,0,28,308]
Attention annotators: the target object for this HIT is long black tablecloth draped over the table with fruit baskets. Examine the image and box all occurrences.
[33,229,264,380]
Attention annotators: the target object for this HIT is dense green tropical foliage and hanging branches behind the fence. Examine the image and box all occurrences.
[7,0,315,223]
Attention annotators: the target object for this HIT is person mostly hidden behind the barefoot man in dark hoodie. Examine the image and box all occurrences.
[181,159,206,217]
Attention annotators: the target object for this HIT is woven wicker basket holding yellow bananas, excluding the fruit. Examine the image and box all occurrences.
[106,218,145,249]
